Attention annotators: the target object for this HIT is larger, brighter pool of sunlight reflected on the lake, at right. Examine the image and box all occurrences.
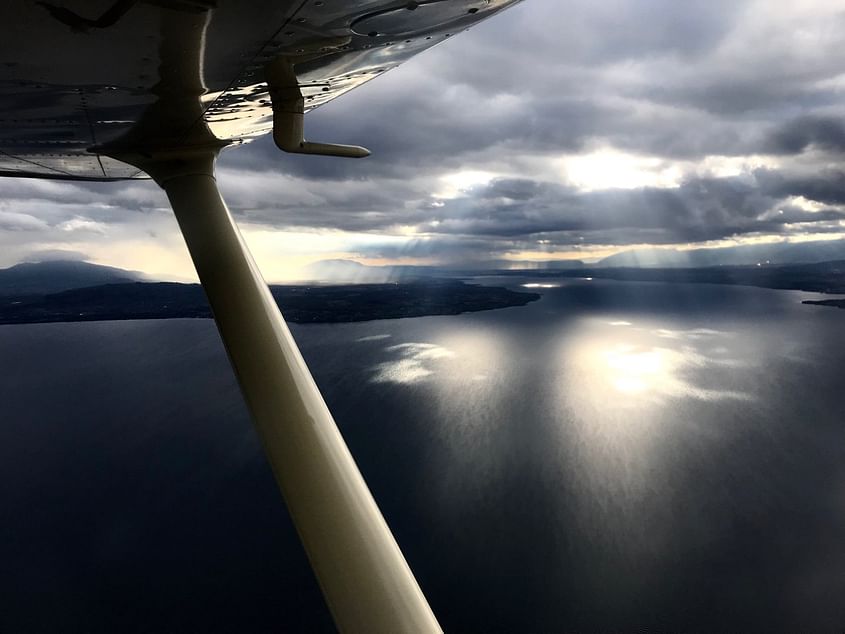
[556,318,754,506]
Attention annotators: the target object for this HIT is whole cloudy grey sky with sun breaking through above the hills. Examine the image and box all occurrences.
[0,0,845,281]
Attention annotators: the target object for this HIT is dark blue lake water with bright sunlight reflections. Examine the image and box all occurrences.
[0,278,845,632]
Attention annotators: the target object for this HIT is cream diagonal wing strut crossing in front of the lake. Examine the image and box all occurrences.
[155,150,441,634]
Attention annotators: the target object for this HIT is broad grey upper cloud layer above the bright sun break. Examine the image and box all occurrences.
[214,0,845,195]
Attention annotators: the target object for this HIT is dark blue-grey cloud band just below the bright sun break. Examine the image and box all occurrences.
[412,173,845,243]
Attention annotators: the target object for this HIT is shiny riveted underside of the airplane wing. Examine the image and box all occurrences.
[0,0,515,181]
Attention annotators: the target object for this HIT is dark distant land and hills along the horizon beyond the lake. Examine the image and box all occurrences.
[0,260,845,324]
